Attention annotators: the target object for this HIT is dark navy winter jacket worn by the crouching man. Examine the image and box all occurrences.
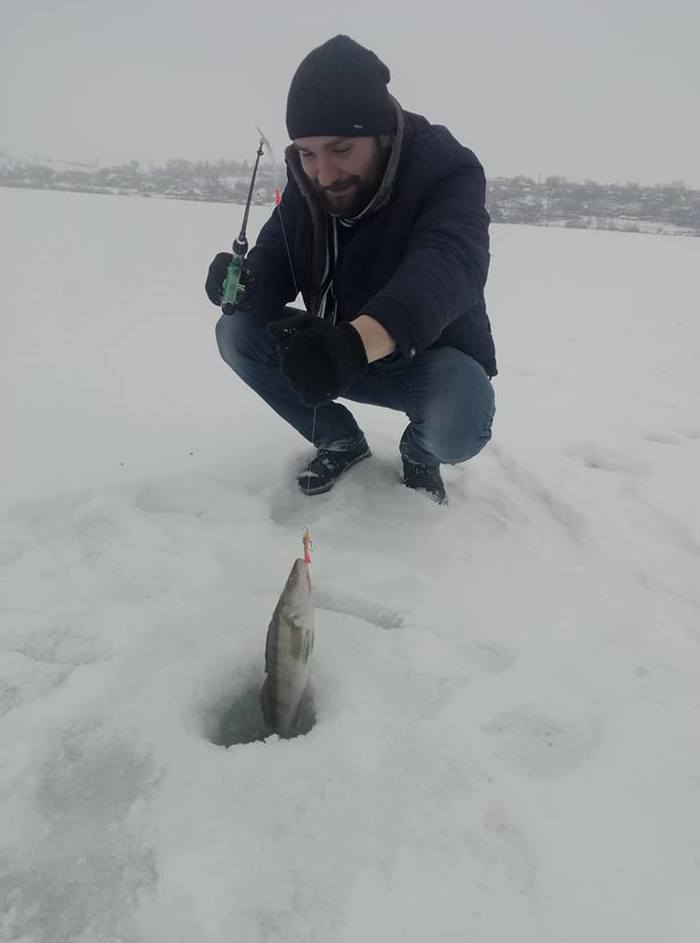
[247,105,497,376]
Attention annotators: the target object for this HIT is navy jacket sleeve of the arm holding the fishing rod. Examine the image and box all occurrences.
[240,184,298,314]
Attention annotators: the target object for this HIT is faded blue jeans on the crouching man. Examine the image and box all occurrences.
[216,308,495,465]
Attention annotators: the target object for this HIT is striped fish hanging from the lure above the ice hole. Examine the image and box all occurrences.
[260,559,315,737]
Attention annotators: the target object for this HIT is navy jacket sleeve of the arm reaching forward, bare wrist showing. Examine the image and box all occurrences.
[362,164,489,358]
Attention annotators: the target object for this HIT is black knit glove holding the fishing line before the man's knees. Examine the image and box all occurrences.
[267,314,367,406]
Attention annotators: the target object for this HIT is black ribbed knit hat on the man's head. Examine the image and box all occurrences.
[287,36,396,140]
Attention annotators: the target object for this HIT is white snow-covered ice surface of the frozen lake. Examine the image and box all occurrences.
[0,189,700,943]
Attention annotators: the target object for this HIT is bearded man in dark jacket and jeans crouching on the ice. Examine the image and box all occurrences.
[206,36,496,503]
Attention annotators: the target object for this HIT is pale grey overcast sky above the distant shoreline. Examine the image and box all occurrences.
[0,0,700,188]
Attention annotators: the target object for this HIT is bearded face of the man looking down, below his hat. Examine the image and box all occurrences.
[294,135,390,216]
